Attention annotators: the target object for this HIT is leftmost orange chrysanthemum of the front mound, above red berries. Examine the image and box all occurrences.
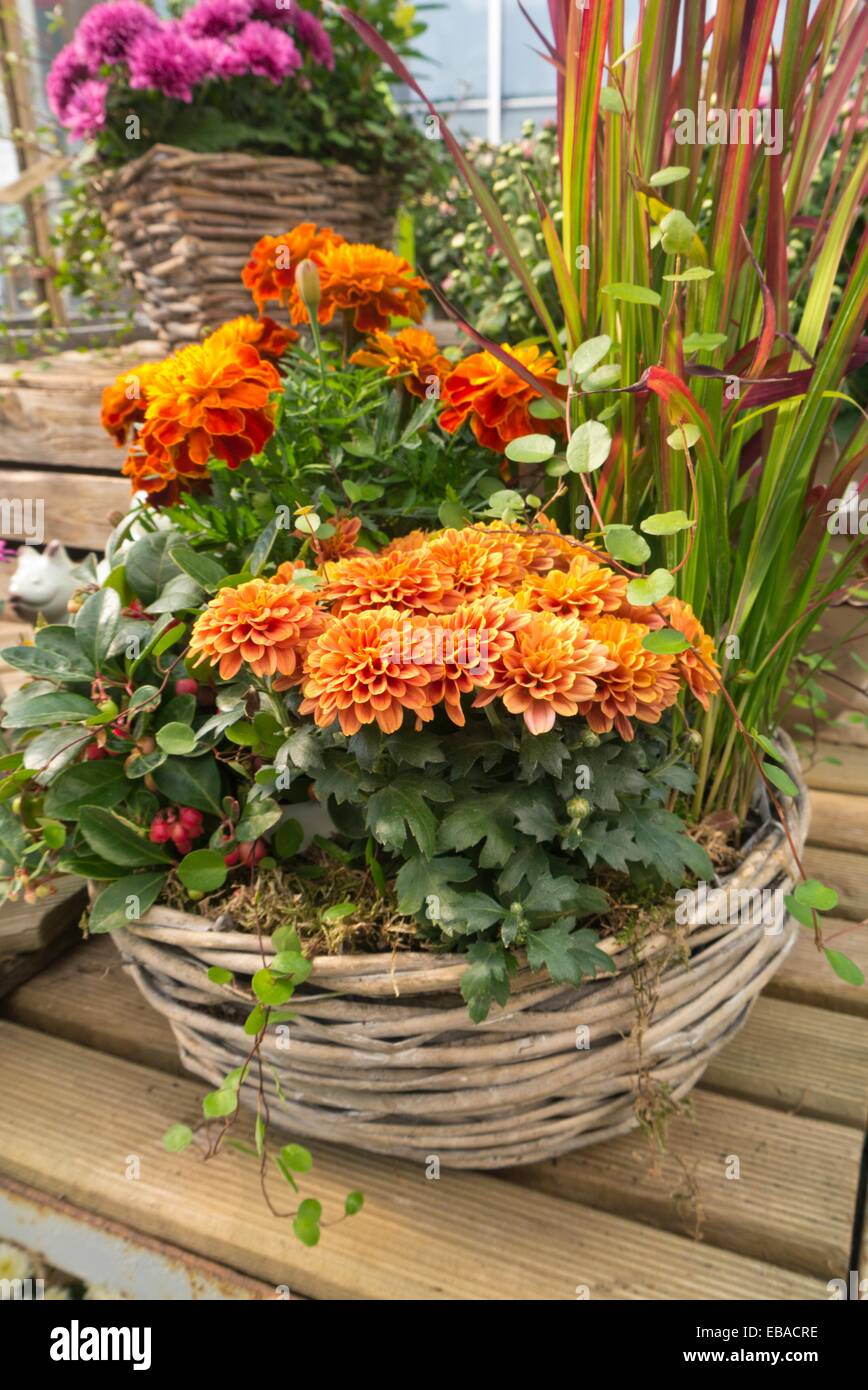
[189,580,326,688]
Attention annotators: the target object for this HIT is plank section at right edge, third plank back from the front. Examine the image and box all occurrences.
[702,995,868,1129]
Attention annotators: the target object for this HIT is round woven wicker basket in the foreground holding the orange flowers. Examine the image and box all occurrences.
[107,739,808,1169]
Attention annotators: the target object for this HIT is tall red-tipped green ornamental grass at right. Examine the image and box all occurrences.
[342,0,868,816]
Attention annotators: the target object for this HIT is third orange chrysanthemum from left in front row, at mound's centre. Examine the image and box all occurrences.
[415,598,530,727]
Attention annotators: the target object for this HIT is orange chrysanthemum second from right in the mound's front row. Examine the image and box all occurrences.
[579,614,680,744]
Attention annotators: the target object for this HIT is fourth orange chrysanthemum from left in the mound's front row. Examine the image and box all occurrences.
[474,613,612,734]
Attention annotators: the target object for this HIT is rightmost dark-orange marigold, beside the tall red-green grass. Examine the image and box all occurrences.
[440,343,561,453]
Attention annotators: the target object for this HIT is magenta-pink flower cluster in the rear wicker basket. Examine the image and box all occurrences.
[46,0,334,139]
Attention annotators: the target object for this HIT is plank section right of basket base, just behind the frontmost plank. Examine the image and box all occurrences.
[504,1084,862,1277]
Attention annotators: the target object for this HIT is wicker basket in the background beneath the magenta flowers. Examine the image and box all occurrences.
[93,145,398,348]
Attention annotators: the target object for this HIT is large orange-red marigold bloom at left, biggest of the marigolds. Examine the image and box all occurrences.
[140,338,281,473]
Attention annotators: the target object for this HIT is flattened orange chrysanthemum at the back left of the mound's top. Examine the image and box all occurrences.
[321,548,449,613]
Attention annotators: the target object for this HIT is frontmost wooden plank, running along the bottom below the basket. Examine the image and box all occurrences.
[0,1022,829,1300]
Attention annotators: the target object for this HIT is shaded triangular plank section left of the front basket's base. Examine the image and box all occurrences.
[1,937,182,1074]
